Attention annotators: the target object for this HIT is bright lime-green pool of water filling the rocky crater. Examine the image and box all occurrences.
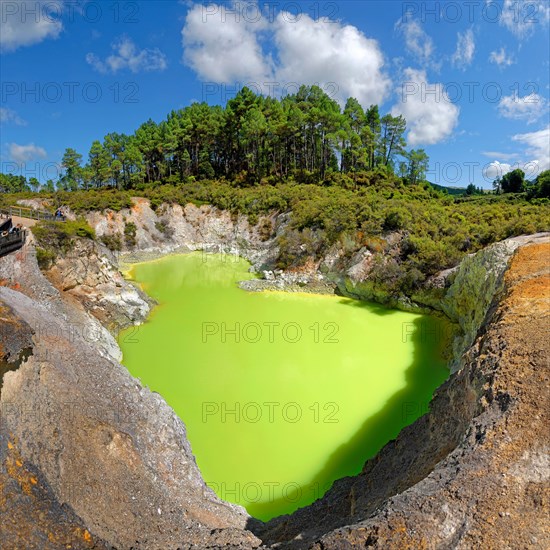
[120,253,448,520]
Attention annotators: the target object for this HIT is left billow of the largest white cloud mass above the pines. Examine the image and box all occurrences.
[181,4,272,84]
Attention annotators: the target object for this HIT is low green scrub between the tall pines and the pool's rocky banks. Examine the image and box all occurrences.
[11,170,550,292]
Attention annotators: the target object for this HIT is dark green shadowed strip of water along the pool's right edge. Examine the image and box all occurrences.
[247,312,449,521]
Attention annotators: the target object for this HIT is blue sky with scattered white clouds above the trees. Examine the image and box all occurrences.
[0,0,550,188]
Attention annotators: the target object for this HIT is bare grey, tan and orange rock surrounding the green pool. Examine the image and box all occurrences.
[0,207,550,550]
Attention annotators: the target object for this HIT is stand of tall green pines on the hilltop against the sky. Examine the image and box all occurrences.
[51,86,428,190]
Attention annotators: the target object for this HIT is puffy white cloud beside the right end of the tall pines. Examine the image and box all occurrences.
[392,68,460,147]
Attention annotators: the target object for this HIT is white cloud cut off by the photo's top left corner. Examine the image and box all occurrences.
[0,0,63,52]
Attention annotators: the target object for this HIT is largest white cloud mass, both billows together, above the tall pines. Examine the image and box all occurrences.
[182,1,391,105]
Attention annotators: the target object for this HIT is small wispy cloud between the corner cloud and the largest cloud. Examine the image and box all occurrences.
[86,37,167,74]
